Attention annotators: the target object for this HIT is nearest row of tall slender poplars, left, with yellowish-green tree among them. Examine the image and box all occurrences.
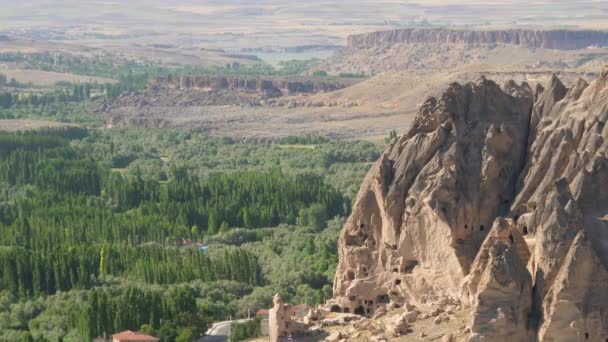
[0,244,263,298]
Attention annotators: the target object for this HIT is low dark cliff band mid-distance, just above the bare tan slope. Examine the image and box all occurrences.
[150,75,350,97]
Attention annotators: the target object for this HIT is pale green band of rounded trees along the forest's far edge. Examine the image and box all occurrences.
[73,129,380,199]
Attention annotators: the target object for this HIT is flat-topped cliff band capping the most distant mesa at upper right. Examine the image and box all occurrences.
[348,28,608,50]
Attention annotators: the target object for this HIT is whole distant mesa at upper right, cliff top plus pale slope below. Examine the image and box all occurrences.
[317,28,608,75]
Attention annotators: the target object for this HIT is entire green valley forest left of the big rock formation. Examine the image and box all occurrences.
[0,126,379,341]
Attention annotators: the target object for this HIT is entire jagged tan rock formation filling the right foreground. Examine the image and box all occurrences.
[328,68,608,341]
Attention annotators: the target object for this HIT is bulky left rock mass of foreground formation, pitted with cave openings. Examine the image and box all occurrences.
[334,79,532,314]
